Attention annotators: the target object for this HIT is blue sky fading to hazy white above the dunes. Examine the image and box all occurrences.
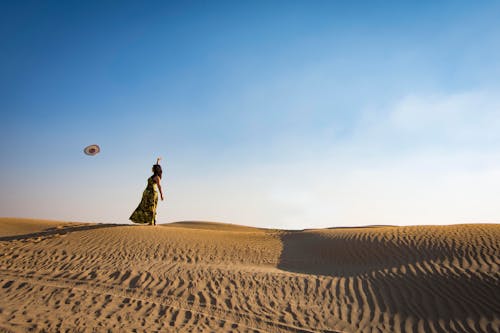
[0,0,500,229]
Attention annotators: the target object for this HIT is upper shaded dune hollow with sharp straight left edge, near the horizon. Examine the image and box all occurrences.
[278,227,482,277]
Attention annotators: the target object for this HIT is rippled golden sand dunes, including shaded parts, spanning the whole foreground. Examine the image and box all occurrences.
[0,219,500,332]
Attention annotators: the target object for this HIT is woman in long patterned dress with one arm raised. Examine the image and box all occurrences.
[130,158,163,225]
